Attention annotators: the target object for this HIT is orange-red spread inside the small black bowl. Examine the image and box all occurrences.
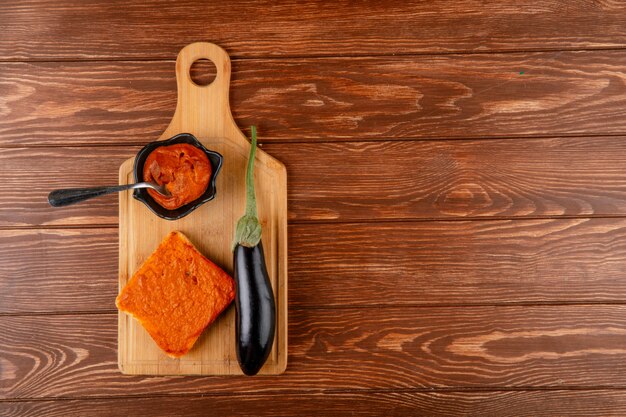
[143,143,212,210]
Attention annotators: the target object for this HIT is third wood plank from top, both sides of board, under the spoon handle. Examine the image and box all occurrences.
[6,136,626,227]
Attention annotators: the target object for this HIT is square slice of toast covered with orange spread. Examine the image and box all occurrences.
[115,232,235,357]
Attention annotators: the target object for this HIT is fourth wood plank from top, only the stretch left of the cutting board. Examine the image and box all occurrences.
[0,229,118,312]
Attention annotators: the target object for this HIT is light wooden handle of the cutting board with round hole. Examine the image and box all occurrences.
[161,42,246,142]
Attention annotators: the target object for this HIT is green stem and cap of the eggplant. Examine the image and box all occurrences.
[233,126,261,248]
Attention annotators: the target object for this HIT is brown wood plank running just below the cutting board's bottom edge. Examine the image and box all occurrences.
[0,305,626,399]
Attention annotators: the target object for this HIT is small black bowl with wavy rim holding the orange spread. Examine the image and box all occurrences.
[133,133,224,220]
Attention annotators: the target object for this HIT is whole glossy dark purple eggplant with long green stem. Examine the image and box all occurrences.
[234,126,276,375]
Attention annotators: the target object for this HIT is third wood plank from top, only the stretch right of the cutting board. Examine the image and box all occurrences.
[276,137,626,221]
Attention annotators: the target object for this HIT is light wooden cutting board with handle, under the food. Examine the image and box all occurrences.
[118,43,287,375]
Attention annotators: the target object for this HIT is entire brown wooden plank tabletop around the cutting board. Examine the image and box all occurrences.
[0,0,626,416]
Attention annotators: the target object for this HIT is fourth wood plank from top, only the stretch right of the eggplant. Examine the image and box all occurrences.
[290,219,626,307]
